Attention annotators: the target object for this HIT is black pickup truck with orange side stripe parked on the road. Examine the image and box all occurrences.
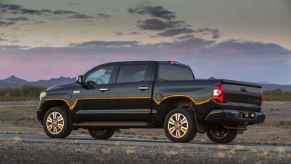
[37,61,265,143]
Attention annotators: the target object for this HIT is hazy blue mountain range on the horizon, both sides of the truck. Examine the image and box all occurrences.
[0,75,291,91]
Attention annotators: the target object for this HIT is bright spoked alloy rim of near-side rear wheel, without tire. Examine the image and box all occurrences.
[168,113,189,138]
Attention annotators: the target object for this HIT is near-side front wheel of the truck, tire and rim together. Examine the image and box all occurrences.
[43,107,72,138]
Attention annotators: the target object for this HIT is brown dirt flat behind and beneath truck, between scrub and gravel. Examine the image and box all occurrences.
[0,101,291,145]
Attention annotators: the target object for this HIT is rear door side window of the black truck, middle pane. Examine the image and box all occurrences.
[117,64,147,83]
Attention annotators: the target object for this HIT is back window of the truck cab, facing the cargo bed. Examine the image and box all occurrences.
[158,64,194,81]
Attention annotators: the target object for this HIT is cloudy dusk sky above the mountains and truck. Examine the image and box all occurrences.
[0,0,291,84]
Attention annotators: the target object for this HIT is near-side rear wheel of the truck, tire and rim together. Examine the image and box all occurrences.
[164,107,197,142]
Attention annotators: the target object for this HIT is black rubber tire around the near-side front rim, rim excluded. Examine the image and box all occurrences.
[42,106,72,138]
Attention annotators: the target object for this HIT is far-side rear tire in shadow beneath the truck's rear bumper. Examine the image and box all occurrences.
[206,126,237,144]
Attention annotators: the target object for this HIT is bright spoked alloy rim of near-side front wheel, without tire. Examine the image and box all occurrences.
[46,112,65,134]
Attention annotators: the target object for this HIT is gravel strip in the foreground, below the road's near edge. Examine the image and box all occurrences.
[0,140,291,164]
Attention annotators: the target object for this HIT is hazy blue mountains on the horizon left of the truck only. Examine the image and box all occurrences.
[0,75,75,88]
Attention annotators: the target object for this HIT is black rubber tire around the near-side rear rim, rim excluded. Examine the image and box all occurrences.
[164,105,197,143]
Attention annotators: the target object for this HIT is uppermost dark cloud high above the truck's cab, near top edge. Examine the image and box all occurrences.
[128,5,176,20]
